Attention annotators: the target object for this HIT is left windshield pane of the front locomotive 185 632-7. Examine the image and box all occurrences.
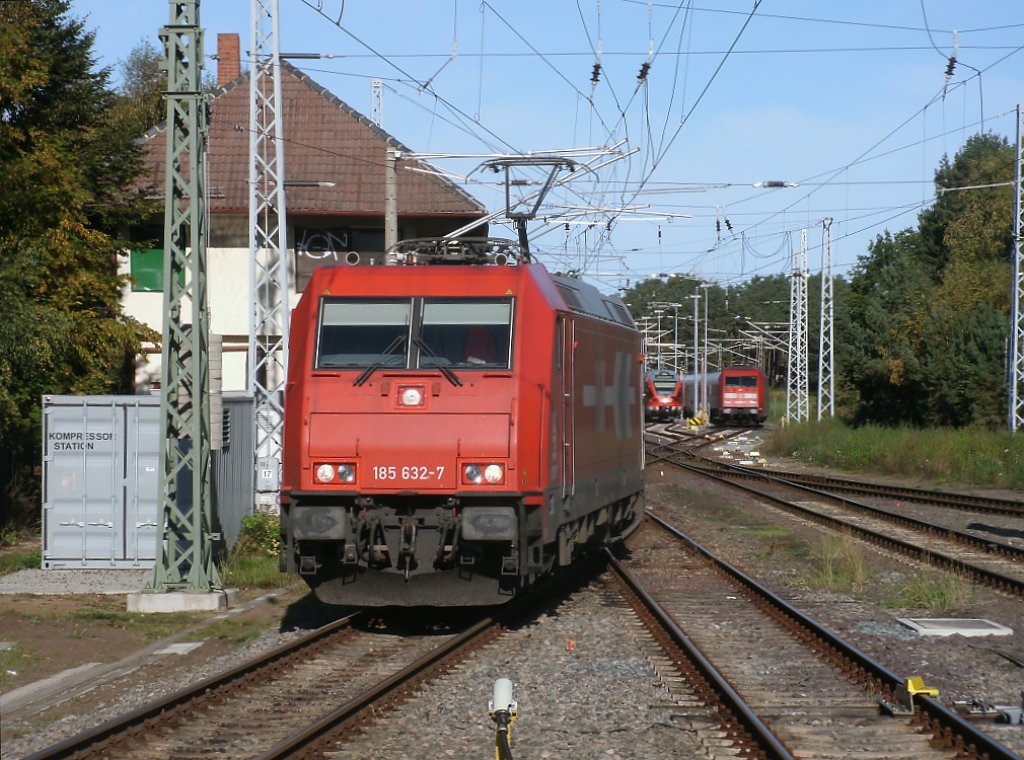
[316,298,412,369]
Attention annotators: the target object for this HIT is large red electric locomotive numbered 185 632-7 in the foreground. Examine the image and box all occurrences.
[281,239,643,606]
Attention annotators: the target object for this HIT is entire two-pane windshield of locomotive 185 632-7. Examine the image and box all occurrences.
[315,298,513,372]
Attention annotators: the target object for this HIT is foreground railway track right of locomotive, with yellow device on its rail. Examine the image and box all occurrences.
[623,517,1019,760]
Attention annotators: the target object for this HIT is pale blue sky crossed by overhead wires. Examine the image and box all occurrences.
[72,0,1024,291]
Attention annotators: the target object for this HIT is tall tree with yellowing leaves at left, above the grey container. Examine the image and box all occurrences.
[0,0,159,518]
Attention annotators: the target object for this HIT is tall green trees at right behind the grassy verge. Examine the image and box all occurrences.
[844,135,1015,426]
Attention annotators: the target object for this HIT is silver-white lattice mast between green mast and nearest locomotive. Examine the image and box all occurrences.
[249,0,289,508]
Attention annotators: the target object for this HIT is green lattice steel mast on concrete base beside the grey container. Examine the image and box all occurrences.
[150,0,220,591]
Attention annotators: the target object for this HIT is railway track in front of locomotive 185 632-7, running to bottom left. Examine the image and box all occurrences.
[23,613,499,760]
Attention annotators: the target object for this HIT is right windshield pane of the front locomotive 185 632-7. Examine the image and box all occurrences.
[417,298,512,370]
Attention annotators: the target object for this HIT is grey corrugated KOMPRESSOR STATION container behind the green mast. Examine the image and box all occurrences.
[42,393,253,569]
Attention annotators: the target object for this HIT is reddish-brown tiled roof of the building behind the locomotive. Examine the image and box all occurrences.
[145,60,486,216]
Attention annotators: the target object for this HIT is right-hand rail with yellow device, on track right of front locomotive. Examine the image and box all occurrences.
[647,510,1020,760]
